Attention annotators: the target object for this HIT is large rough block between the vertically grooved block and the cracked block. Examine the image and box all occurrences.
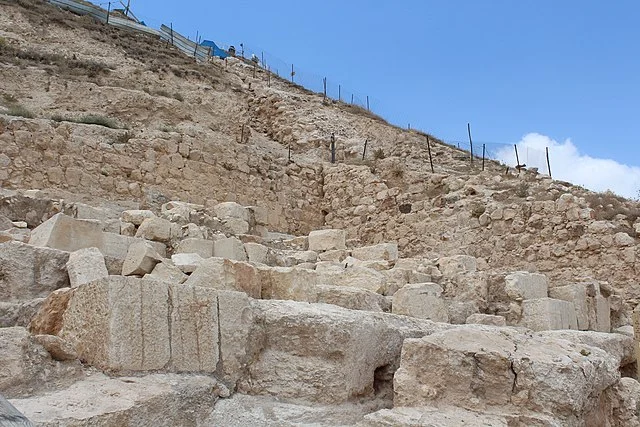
[238,300,439,404]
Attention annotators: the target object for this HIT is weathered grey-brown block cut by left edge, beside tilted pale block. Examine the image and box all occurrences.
[0,241,69,302]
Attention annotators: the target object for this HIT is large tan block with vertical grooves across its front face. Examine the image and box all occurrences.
[59,276,219,372]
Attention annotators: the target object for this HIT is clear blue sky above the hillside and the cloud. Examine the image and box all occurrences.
[105,0,640,196]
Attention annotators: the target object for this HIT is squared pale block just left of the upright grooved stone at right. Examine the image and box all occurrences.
[520,298,578,331]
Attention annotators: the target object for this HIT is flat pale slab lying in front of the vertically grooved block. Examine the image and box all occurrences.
[11,373,224,427]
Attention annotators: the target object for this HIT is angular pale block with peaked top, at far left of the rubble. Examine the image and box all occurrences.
[29,213,106,255]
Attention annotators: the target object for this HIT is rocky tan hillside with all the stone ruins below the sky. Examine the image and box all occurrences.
[0,0,640,426]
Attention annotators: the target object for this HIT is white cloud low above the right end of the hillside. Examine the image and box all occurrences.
[494,133,640,198]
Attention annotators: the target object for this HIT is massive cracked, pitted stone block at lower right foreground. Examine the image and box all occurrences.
[394,325,620,425]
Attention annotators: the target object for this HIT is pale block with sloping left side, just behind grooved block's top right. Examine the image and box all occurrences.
[185,258,262,298]
